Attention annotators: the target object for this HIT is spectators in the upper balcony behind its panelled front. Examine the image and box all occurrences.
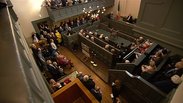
[45,0,91,9]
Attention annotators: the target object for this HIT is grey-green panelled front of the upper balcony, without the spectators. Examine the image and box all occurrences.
[47,0,114,22]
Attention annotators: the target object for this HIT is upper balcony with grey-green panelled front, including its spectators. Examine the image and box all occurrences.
[43,0,114,22]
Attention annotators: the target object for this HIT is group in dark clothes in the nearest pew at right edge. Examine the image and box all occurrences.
[151,58,183,93]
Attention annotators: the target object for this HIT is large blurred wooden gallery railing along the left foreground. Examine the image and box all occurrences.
[0,2,53,103]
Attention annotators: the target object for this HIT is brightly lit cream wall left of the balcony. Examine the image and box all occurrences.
[11,0,48,41]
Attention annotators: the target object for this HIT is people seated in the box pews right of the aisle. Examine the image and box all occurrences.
[79,25,183,93]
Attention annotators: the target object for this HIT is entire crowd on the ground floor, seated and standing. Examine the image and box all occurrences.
[28,10,183,103]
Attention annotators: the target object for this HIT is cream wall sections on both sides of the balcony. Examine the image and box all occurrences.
[11,0,141,39]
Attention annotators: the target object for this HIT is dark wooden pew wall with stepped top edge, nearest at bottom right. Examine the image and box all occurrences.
[109,69,167,103]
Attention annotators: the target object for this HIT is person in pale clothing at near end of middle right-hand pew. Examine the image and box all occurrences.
[141,60,156,74]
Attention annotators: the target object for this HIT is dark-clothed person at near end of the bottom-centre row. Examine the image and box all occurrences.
[91,86,102,103]
